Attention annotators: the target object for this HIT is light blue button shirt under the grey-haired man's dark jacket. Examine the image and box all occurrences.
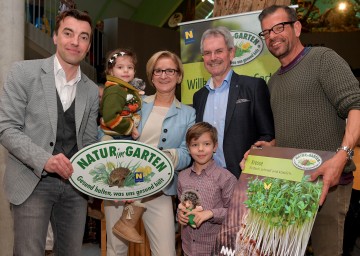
[203,69,233,168]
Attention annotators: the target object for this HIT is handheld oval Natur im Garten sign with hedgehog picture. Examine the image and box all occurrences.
[70,140,174,200]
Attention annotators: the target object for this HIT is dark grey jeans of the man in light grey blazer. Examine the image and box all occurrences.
[11,174,87,256]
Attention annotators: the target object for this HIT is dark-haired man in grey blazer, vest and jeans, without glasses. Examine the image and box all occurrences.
[0,10,99,256]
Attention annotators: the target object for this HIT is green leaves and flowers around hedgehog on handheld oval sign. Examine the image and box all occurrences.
[89,162,155,187]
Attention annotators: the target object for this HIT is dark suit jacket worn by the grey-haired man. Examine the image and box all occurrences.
[193,72,275,178]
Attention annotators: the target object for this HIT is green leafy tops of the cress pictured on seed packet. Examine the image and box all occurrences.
[244,176,322,227]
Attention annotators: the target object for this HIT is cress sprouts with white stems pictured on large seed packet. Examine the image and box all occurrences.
[241,176,322,256]
